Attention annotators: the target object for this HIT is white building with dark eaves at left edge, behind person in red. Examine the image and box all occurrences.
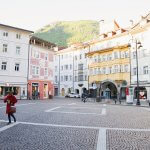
[0,24,32,98]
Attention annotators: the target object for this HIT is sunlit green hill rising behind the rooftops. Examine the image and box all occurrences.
[35,20,99,46]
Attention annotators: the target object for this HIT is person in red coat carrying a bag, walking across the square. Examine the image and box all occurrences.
[4,91,17,124]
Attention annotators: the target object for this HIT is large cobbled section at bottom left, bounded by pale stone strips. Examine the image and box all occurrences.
[0,124,98,150]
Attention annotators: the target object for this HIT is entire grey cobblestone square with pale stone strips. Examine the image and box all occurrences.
[0,98,150,150]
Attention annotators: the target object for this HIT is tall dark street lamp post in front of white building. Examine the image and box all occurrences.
[129,39,142,105]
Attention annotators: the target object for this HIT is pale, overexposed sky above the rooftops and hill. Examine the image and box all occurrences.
[0,0,150,31]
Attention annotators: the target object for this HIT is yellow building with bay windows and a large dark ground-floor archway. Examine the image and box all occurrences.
[87,21,130,99]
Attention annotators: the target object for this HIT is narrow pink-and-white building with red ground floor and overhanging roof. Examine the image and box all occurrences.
[28,36,55,99]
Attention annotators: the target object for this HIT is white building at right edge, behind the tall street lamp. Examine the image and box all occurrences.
[130,14,150,100]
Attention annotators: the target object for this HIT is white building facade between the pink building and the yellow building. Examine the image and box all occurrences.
[54,45,88,96]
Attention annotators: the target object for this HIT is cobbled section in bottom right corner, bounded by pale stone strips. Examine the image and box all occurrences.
[106,130,150,150]
